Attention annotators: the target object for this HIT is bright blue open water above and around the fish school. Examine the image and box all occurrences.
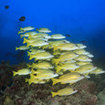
[0,0,105,63]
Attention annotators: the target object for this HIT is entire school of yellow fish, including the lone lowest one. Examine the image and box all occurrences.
[13,26,105,97]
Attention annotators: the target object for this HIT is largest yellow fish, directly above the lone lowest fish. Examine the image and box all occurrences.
[52,73,85,85]
